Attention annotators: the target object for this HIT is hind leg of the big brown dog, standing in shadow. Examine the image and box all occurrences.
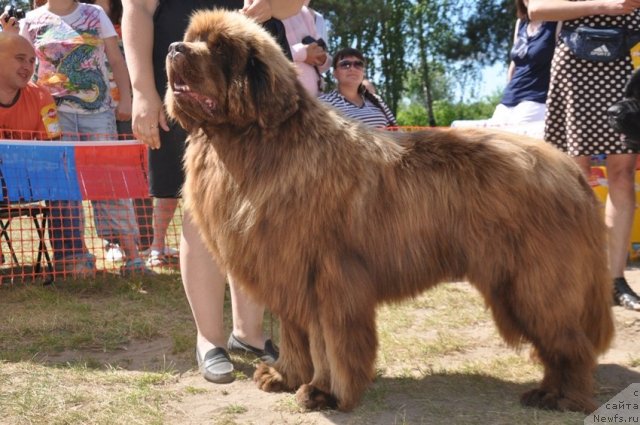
[485,279,596,413]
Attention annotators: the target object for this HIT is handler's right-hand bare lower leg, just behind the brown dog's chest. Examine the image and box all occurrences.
[229,276,266,349]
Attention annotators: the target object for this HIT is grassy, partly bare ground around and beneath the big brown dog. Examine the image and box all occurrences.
[0,274,637,425]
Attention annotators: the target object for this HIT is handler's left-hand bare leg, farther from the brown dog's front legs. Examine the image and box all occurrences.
[180,211,226,358]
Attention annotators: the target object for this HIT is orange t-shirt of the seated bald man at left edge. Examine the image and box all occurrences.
[0,82,61,140]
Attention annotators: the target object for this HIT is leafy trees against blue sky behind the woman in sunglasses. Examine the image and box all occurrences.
[312,0,515,125]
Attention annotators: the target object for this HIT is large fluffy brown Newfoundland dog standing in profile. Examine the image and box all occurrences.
[166,11,613,412]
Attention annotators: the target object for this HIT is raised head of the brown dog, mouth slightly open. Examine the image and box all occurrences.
[165,10,299,132]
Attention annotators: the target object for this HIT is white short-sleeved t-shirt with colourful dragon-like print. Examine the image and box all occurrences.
[20,3,117,114]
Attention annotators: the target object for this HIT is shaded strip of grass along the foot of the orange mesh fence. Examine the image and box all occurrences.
[0,275,190,361]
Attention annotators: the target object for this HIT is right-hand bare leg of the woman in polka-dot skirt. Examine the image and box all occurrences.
[605,155,636,278]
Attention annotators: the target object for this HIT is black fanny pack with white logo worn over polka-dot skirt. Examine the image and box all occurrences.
[560,25,640,62]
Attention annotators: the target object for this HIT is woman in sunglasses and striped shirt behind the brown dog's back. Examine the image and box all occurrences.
[320,48,398,127]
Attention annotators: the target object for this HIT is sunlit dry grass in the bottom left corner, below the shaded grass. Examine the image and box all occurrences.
[0,362,177,424]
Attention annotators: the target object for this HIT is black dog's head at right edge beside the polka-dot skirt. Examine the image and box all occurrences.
[607,69,640,149]
